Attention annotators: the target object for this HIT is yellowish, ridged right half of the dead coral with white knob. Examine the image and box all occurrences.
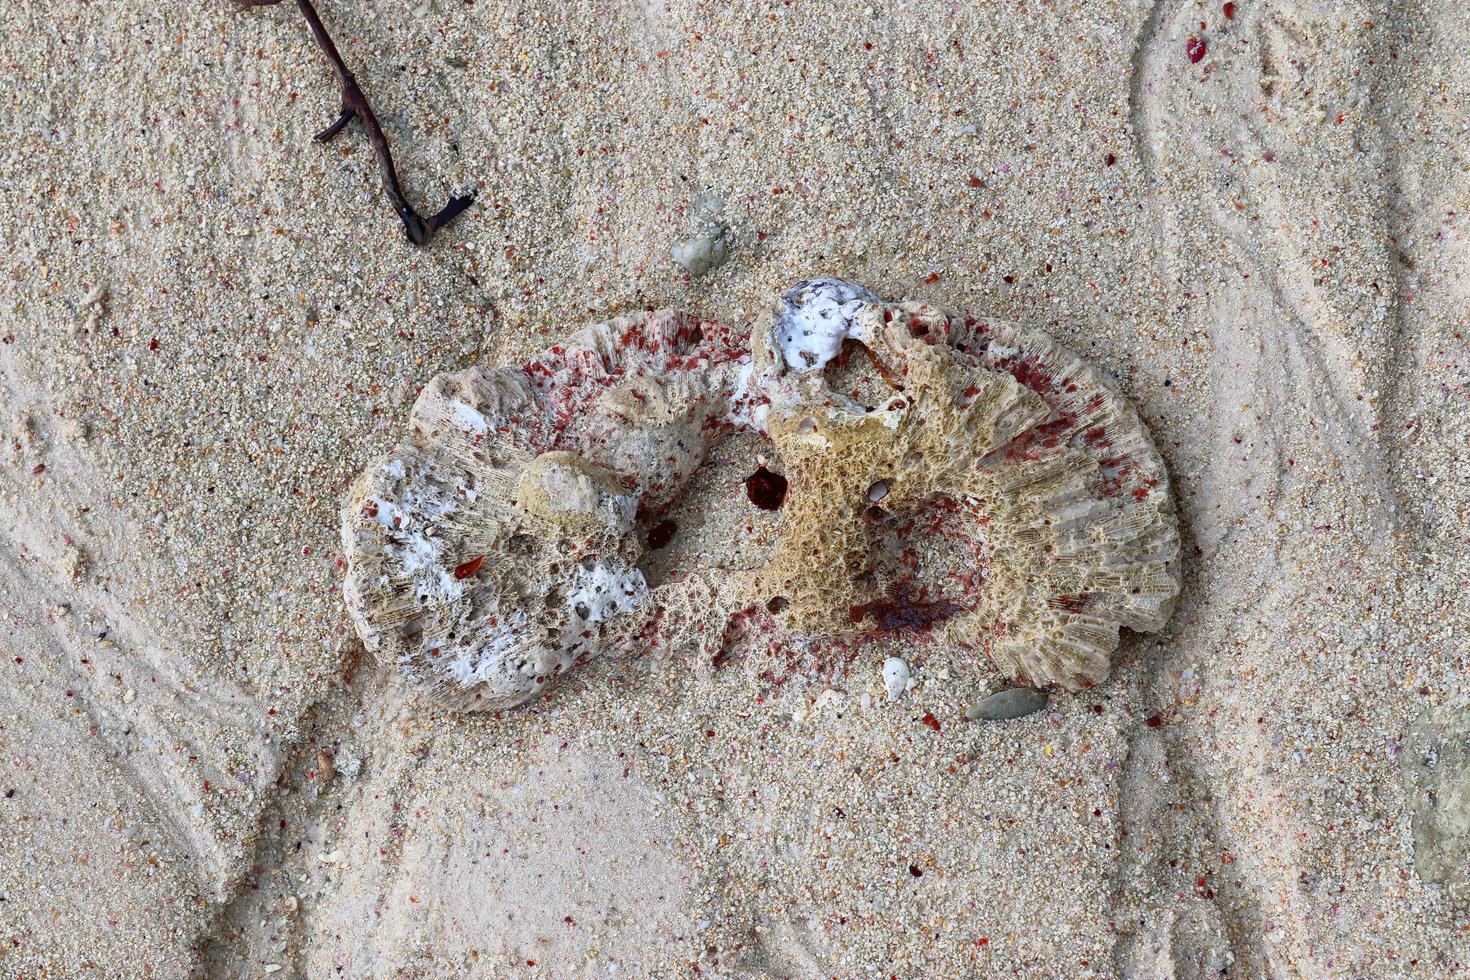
[751,279,1179,691]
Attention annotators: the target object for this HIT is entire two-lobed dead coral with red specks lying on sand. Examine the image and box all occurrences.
[343,279,1179,710]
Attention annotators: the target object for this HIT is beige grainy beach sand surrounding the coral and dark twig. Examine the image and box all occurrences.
[0,0,1470,977]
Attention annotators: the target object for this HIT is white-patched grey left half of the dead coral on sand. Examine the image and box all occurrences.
[343,311,748,710]
